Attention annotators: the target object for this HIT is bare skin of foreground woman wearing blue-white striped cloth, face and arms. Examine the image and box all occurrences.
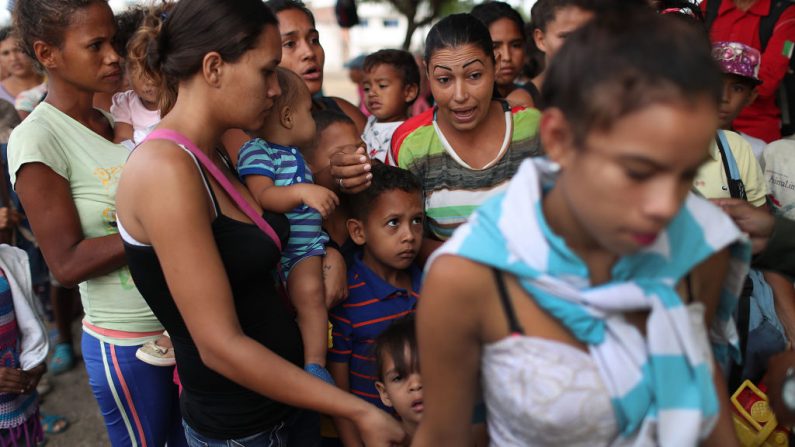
[412,98,737,446]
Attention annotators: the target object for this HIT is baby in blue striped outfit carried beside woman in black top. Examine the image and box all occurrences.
[237,68,339,383]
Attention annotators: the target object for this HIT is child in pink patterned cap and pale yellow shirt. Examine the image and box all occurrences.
[694,42,767,206]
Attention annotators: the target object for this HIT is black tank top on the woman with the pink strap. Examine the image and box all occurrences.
[124,166,303,439]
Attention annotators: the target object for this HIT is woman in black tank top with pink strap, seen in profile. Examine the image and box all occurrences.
[117,0,405,446]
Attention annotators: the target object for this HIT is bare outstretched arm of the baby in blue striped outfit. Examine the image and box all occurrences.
[245,175,339,218]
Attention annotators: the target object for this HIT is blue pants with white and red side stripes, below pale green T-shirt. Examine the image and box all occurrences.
[82,332,187,447]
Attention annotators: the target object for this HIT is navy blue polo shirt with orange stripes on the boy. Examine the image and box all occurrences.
[328,252,422,411]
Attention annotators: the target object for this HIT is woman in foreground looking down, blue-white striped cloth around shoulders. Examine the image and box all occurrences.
[413,10,748,446]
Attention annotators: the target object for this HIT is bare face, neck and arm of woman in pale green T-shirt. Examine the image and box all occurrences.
[15,3,126,286]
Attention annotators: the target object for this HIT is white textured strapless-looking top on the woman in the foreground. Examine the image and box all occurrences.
[481,335,619,447]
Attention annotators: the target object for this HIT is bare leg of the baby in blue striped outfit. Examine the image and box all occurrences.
[287,256,328,366]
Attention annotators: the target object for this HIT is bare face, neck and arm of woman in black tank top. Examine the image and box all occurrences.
[117,26,405,446]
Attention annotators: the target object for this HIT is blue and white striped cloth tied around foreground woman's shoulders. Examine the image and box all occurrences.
[436,159,750,447]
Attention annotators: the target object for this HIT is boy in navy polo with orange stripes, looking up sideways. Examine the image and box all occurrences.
[327,163,424,445]
